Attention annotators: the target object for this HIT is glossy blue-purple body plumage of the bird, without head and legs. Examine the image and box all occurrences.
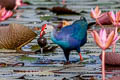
[51,17,88,48]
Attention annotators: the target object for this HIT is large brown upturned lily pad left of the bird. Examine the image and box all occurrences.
[0,23,37,50]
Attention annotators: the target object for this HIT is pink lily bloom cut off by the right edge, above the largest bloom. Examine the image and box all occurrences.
[108,11,120,26]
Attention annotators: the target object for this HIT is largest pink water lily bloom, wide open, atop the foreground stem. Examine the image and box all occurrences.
[92,28,116,50]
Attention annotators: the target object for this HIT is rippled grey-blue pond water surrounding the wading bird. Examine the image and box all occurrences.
[0,0,120,80]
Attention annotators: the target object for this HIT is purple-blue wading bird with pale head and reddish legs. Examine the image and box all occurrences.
[42,17,94,64]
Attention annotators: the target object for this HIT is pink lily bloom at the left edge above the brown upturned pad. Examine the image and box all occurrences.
[0,8,13,21]
